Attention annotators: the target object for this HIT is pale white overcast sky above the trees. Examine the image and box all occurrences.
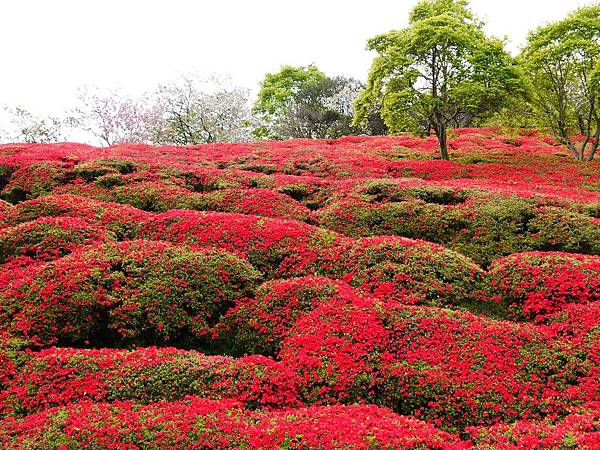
[0,0,591,118]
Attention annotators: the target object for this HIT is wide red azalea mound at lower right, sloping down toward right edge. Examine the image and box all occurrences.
[382,307,590,430]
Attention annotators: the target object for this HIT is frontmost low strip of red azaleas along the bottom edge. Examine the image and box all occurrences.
[0,397,469,450]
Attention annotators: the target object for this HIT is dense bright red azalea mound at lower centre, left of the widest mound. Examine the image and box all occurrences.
[279,298,390,404]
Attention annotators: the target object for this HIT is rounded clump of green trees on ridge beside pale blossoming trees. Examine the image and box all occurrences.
[253,65,363,139]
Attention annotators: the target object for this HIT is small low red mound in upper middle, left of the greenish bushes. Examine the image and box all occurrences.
[195,189,310,221]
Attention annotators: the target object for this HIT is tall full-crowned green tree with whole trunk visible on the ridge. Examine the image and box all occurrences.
[354,0,524,159]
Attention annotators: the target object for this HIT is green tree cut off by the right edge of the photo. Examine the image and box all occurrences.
[519,5,600,161]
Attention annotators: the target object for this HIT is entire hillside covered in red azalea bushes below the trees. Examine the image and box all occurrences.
[0,129,600,449]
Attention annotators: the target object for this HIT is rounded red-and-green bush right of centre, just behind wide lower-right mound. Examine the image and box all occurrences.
[332,236,485,308]
